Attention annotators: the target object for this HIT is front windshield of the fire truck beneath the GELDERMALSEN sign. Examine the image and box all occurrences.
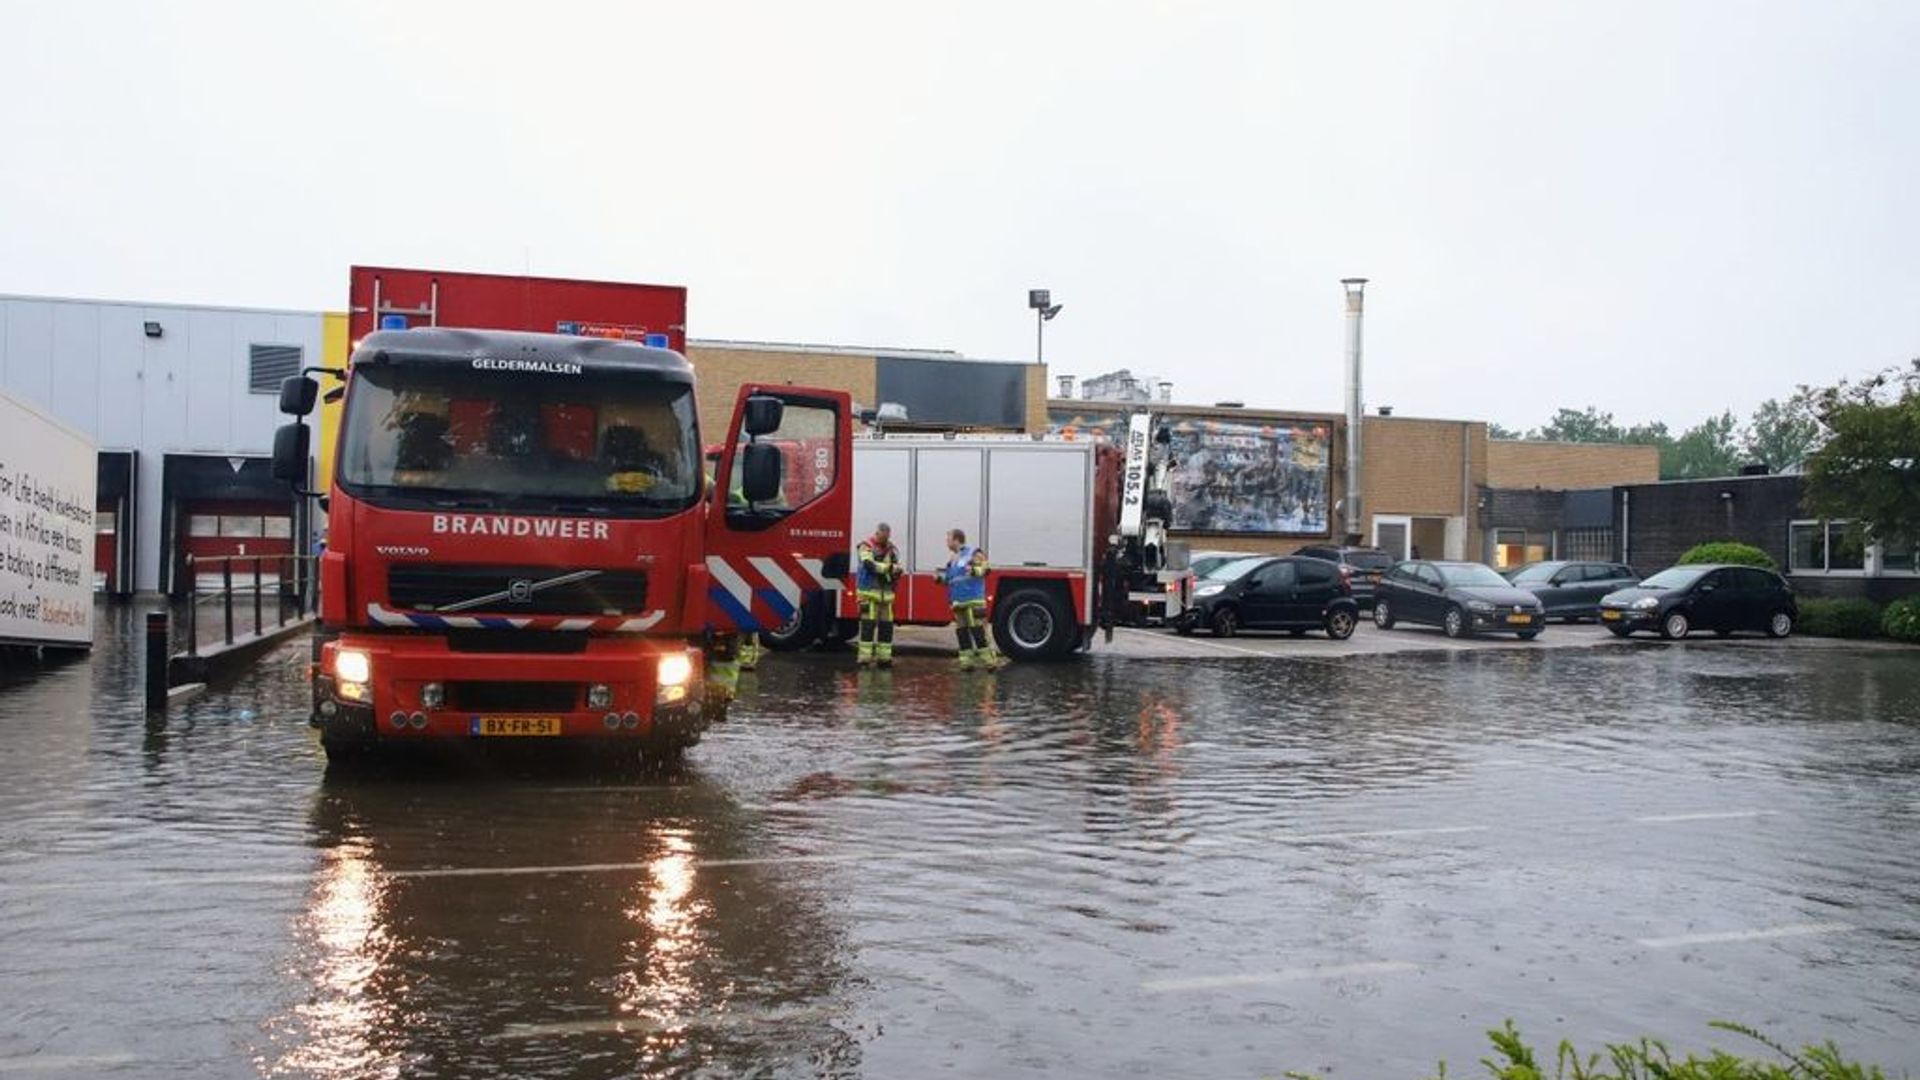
[338,365,701,517]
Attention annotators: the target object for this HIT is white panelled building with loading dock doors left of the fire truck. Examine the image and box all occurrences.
[0,296,326,596]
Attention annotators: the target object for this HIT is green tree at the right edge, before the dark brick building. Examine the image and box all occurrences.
[1807,359,1920,540]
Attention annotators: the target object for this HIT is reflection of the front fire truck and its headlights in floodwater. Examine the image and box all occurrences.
[263,774,858,1076]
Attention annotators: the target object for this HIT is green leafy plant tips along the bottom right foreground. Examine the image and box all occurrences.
[1286,1020,1885,1080]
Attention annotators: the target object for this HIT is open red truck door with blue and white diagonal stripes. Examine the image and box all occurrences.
[697,384,852,630]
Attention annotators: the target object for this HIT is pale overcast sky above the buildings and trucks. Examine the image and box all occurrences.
[0,0,1920,427]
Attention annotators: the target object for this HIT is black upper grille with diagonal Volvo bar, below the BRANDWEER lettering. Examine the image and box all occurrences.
[386,563,647,615]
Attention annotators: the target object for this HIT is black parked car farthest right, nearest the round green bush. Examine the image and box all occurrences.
[1599,567,1799,640]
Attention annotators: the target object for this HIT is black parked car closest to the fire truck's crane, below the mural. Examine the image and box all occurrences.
[1177,555,1359,642]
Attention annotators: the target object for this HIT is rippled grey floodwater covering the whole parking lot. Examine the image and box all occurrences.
[0,599,1920,1078]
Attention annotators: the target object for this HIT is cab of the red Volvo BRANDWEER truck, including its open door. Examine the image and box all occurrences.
[275,322,852,757]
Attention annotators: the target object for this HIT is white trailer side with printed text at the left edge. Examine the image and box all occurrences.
[0,394,100,650]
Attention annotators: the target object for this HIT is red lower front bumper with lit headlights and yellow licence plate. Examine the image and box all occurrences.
[311,634,710,744]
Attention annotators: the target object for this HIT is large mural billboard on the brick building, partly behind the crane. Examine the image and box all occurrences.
[1048,407,1332,536]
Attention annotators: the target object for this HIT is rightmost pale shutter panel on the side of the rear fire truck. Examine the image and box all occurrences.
[981,446,1092,567]
